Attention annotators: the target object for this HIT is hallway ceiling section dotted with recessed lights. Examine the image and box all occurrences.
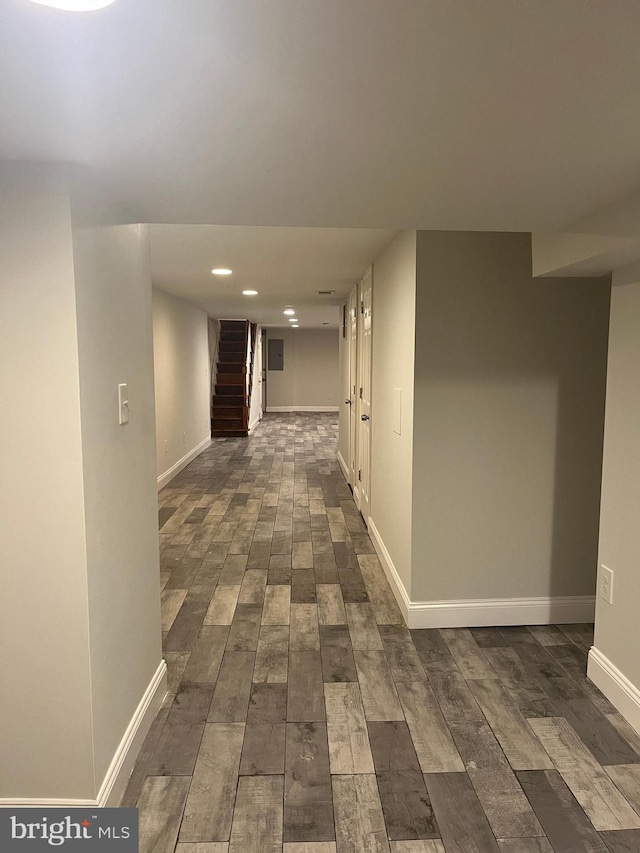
[151,225,394,328]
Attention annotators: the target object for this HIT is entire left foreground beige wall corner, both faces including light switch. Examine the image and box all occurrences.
[0,164,166,804]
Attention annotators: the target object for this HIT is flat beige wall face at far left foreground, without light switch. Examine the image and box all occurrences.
[0,163,94,798]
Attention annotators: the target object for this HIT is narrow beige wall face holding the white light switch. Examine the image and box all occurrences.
[73,218,162,786]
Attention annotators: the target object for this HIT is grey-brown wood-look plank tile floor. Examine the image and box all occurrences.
[123,415,640,853]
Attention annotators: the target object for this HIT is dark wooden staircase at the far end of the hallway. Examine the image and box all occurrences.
[211,320,257,438]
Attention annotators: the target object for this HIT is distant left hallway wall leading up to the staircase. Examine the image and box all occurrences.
[153,287,211,479]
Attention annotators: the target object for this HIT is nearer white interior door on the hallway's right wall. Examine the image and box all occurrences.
[354,268,373,525]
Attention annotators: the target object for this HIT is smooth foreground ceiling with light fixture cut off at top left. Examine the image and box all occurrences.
[0,0,640,231]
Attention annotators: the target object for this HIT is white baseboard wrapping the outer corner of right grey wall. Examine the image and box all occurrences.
[369,519,596,628]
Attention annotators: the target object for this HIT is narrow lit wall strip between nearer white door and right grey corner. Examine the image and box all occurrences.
[368,231,416,595]
